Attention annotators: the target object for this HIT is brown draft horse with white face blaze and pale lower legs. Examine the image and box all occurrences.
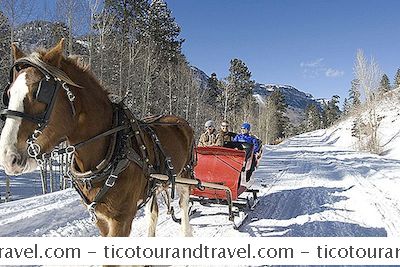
[0,40,193,236]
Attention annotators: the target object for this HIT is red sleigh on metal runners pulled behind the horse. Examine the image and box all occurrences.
[191,142,258,228]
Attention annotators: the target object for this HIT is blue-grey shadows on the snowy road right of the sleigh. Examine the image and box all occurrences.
[240,187,387,237]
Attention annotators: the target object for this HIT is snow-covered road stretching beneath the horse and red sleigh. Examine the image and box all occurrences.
[0,129,400,237]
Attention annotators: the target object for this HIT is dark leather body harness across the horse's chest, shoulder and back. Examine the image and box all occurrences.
[70,104,184,221]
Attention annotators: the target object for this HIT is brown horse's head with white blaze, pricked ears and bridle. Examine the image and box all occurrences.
[0,40,76,175]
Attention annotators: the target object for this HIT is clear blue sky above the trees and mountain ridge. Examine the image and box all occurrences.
[166,0,400,100]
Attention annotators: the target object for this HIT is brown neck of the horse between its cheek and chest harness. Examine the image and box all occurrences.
[68,84,113,172]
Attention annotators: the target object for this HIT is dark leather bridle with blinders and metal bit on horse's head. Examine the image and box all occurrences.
[0,54,81,168]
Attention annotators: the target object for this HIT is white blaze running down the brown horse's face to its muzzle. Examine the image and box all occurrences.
[0,72,37,175]
